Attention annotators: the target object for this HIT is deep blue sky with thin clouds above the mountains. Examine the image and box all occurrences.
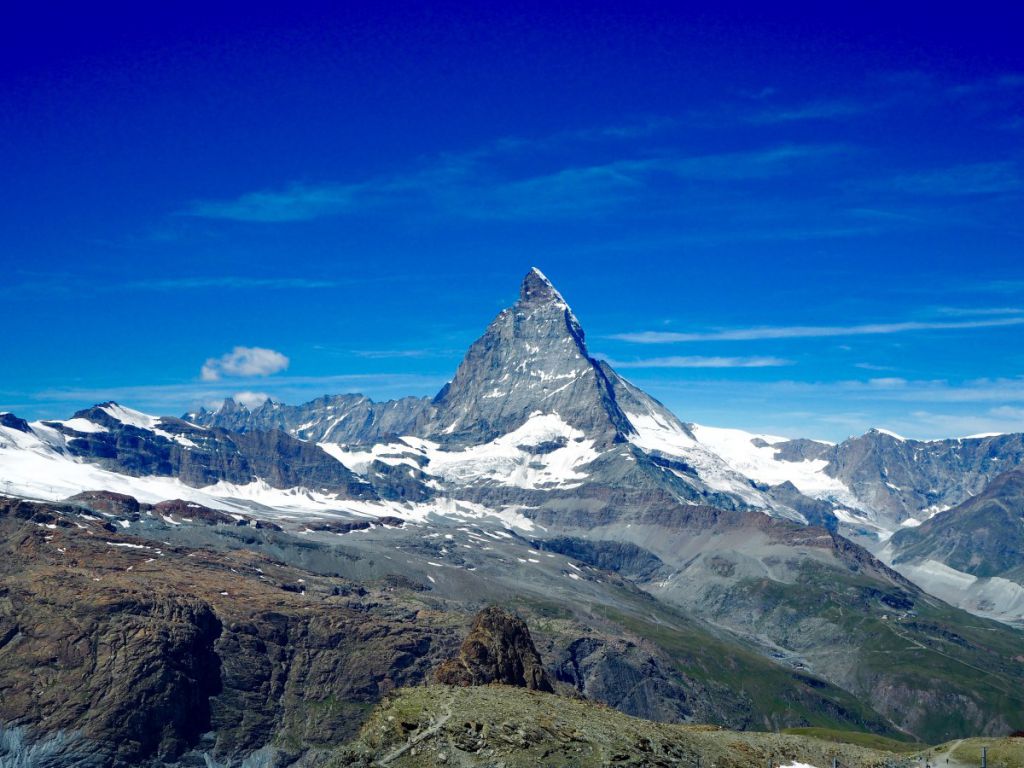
[0,3,1024,439]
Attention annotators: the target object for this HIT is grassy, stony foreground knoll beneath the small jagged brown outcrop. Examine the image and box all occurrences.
[335,685,913,768]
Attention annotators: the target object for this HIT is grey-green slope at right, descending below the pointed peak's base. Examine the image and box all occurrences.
[552,509,1024,741]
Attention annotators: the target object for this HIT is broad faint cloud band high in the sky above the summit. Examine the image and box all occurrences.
[180,144,853,223]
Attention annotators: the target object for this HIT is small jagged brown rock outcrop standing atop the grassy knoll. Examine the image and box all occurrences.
[435,606,554,692]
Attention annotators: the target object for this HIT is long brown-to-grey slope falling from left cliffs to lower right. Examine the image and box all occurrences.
[0,494,913,766]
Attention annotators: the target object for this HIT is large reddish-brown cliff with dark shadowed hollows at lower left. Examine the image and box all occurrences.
[0,500,455,768]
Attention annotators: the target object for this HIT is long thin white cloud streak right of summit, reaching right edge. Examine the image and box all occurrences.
[609,317,1024,344]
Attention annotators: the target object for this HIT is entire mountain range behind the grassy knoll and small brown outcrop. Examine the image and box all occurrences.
[0,269,1024,765]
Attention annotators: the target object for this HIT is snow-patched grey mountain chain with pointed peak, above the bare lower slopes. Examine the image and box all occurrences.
[8,268,1024,546]
